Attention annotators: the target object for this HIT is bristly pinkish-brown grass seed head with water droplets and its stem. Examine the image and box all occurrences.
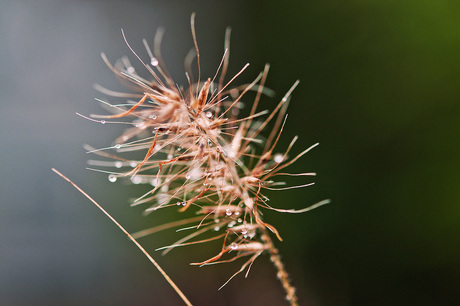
[56,15,329,305]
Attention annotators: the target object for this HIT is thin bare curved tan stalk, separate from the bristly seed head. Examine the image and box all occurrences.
[52,168,192,306]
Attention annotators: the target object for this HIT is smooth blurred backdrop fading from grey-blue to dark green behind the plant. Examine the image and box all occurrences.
[0,0,460,305]
